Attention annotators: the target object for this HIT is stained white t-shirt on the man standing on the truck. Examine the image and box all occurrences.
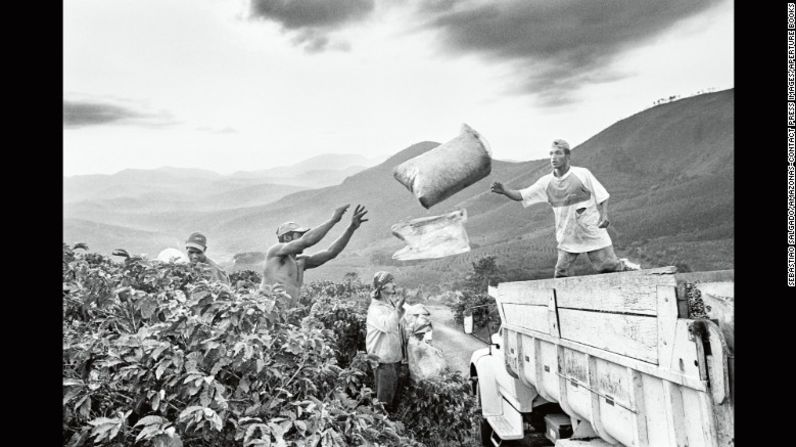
[520,166,611,253]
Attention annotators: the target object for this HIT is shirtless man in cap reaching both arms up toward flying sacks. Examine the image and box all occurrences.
[260,205,367,302]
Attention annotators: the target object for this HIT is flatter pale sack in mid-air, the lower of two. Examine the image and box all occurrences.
[390,209,470,261]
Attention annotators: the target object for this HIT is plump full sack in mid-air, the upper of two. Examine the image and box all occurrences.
[393,124,492,209]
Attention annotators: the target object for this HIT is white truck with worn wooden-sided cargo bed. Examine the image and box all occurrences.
[464,267,735,447]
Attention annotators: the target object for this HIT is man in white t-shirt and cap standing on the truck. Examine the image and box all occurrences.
[491,140,640,278]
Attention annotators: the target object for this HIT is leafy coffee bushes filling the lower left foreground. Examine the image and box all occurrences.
[63,245,473,447]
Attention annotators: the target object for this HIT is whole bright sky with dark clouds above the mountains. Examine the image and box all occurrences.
[63,0,734,175]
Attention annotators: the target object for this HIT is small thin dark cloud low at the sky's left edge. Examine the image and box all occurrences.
[63,100,175,128]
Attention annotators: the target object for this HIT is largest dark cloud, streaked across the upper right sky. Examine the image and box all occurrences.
[420,0,725,106]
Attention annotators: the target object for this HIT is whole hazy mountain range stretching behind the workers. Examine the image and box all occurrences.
[64,89,734,286]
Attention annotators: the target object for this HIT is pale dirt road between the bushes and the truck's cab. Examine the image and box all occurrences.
[426,305,487,377]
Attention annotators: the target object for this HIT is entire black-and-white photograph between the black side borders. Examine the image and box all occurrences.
[62,0,732,447]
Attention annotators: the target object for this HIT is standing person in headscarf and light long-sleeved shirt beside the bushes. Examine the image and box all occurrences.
[365,272,405,411]
